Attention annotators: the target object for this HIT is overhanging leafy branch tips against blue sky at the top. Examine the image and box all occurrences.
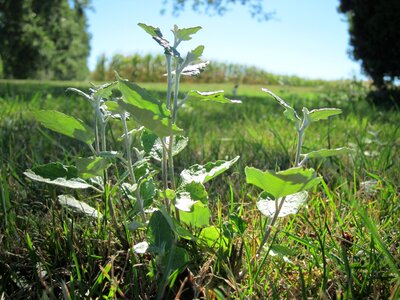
[162,0,271,20]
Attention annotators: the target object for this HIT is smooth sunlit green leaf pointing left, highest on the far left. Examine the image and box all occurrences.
[32,110,94,145]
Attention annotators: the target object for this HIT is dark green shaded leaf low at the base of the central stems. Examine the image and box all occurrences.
[146,210,175,252]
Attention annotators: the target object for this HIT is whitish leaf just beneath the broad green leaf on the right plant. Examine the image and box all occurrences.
[257,191,308,218]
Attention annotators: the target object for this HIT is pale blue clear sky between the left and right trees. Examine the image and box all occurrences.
[88,0,361,79]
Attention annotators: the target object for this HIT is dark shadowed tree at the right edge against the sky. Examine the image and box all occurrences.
[339,0,400,90]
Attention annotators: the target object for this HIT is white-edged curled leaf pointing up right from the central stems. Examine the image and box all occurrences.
[181,156,239,185]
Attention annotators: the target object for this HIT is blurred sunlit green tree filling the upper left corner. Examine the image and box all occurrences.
[0,0,90,80]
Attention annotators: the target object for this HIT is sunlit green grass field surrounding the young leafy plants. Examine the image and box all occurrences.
[0,81,400,299]
